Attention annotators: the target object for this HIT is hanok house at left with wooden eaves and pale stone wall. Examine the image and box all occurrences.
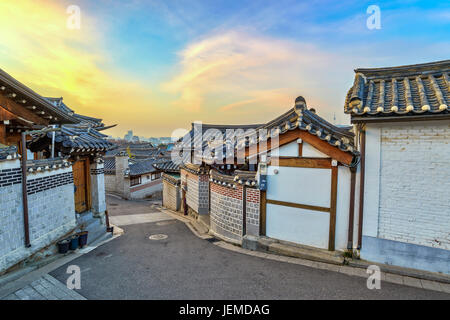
[0,70,113,273]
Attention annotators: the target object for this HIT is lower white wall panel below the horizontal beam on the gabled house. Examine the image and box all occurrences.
[266,204,330,249]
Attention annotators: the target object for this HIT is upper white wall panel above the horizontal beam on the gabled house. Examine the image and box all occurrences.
[267,166,331,208]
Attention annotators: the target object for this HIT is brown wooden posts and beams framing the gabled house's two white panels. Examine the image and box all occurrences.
[260,156,339,251]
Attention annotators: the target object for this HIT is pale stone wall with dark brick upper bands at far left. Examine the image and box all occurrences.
[0,158,76,273]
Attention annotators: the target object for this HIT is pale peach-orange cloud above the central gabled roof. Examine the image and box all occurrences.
[163,30,351,122]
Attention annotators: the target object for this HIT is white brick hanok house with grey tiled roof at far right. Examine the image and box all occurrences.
[344,60,450,274]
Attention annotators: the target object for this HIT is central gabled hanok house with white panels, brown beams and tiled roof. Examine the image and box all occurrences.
[218,97,359,250]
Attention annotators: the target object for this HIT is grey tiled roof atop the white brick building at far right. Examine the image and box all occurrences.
[344,60,450,118]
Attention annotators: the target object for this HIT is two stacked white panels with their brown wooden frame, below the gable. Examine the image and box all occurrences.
[260,156,338,251]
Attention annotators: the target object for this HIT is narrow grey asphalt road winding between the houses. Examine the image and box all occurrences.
[51,198,450,299]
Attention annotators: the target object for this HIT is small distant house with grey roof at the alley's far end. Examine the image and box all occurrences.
[105,151,166,199]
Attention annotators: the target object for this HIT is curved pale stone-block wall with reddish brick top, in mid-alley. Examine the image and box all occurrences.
[210,183,243,240]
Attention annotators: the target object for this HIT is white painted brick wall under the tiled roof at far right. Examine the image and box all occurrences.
[378,122,450,250]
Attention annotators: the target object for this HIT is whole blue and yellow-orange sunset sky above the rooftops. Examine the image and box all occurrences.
[0,0,450,137]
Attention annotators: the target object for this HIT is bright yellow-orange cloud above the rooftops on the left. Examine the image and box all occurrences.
[0,0,174,135]
